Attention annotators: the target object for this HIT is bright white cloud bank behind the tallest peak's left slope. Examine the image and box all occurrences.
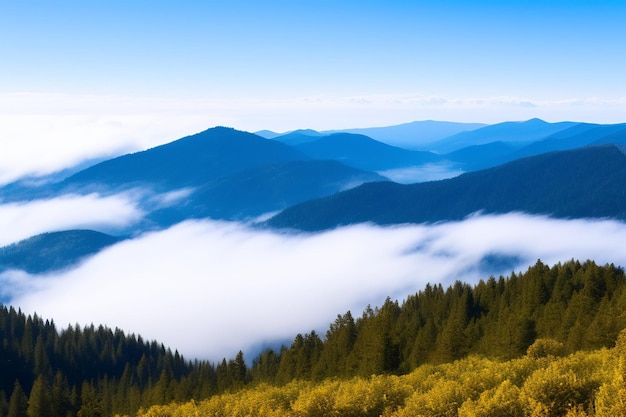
[0,93,228,185]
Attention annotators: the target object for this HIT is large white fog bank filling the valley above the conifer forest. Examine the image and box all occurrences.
[0,214,626,360]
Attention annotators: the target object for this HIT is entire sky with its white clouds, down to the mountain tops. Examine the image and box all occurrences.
[0,0,626,182]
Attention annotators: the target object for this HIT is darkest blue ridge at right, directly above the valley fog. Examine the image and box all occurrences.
[268,146,626,230]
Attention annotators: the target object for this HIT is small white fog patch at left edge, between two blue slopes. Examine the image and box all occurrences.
[0,193,143,246]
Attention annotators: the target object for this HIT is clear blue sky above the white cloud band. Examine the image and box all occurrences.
[0,1,626,107]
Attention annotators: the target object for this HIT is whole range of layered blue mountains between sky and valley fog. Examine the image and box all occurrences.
[0,119,626,273]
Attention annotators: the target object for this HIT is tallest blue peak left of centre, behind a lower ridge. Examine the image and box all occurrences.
[60,127,308,189]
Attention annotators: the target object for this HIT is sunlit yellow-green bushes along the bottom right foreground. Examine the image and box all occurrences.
[137,331,626,417]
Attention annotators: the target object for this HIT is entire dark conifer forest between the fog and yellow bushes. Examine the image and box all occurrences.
[0,260,626,417]
